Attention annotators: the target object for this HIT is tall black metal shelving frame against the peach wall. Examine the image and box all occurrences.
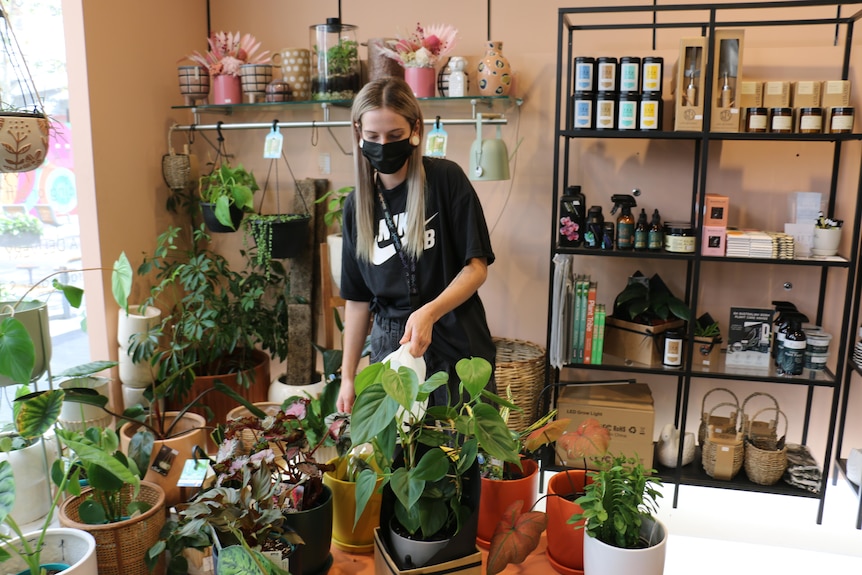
[544,0,862,523]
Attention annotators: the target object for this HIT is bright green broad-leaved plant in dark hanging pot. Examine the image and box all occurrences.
[199,162,260,232]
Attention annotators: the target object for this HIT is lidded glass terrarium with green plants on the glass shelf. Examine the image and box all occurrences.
[309,18,360,100]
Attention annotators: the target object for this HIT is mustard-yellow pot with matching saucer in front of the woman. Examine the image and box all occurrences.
[323,459,383,553]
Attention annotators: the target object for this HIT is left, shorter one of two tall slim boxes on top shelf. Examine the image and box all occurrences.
[673,36,706,132]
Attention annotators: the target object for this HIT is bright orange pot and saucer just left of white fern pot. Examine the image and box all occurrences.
[546,469,586,575]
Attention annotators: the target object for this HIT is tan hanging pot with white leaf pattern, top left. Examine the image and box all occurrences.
[0,112,48,173]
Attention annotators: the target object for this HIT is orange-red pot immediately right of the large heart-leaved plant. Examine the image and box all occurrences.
[476,459,539,549]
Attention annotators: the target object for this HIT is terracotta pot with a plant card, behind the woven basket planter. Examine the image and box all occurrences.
[120,412,207,507]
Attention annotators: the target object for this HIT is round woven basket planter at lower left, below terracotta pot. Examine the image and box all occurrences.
[59,481,165,575]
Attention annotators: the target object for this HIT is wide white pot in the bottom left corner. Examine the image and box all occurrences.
[0,527,99,575]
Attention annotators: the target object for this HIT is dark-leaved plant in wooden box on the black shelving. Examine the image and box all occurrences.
[613,271,690,325]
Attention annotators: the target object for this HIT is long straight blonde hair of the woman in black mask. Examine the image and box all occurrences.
[350,77,425,262]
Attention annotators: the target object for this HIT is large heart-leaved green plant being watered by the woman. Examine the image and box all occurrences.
[350,357,520,539]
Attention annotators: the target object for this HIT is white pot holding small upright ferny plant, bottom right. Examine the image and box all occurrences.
[584,519,667,575]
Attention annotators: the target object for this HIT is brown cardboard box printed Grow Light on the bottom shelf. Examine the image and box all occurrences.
[557,383,655,469]
